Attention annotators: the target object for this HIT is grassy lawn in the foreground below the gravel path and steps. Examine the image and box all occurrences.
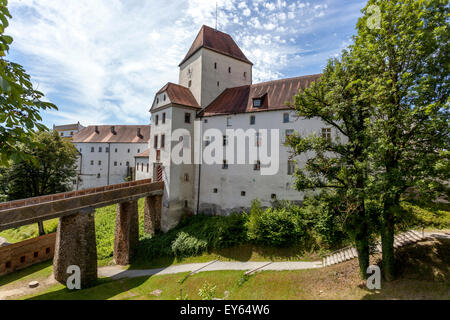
[17,240,450,300]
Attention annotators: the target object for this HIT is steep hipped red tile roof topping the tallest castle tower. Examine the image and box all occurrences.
[179,25,253,66]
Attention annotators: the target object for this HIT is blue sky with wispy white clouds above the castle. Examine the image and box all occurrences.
[6,0,366,127]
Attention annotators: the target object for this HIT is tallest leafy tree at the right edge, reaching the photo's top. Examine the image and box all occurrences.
[351,0,450,280]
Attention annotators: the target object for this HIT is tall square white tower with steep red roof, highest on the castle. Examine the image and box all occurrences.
[179,26,253,108]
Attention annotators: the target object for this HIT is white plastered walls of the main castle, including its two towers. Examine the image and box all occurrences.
[149,25,326,231]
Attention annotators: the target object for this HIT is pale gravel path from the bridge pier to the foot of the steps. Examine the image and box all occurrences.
[98,260,322,279]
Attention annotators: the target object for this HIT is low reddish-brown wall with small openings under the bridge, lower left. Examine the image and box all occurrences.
[0,233,56,276]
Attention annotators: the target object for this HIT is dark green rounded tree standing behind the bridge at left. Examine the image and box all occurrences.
[0,131,78,235]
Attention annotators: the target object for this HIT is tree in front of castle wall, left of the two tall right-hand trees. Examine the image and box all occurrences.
[288,51,373,278]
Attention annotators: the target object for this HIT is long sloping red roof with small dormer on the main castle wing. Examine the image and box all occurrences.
[199,74,321,116]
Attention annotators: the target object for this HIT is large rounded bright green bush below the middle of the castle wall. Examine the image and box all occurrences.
[247,200,306,246]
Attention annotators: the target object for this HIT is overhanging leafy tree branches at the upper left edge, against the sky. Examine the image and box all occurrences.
[0,0,57,165]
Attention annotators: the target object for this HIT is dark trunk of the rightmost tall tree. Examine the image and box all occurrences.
[381,201,395,281]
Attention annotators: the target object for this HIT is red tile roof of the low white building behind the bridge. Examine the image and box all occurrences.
[72,125,150,143]
